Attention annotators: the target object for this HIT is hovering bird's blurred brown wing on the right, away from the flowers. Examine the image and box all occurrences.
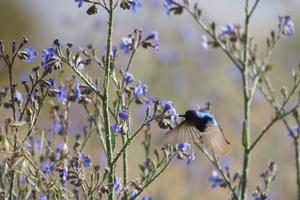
[200,125,230,157]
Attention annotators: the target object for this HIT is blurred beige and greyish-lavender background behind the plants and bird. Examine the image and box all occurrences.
[0,0,300,200]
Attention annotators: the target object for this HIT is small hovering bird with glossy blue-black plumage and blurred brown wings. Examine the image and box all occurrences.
[167,109,230,157]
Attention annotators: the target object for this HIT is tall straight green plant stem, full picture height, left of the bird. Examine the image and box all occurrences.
[103,0,115,200]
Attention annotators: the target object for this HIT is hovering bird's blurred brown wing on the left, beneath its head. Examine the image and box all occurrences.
[166,120,203,145]
